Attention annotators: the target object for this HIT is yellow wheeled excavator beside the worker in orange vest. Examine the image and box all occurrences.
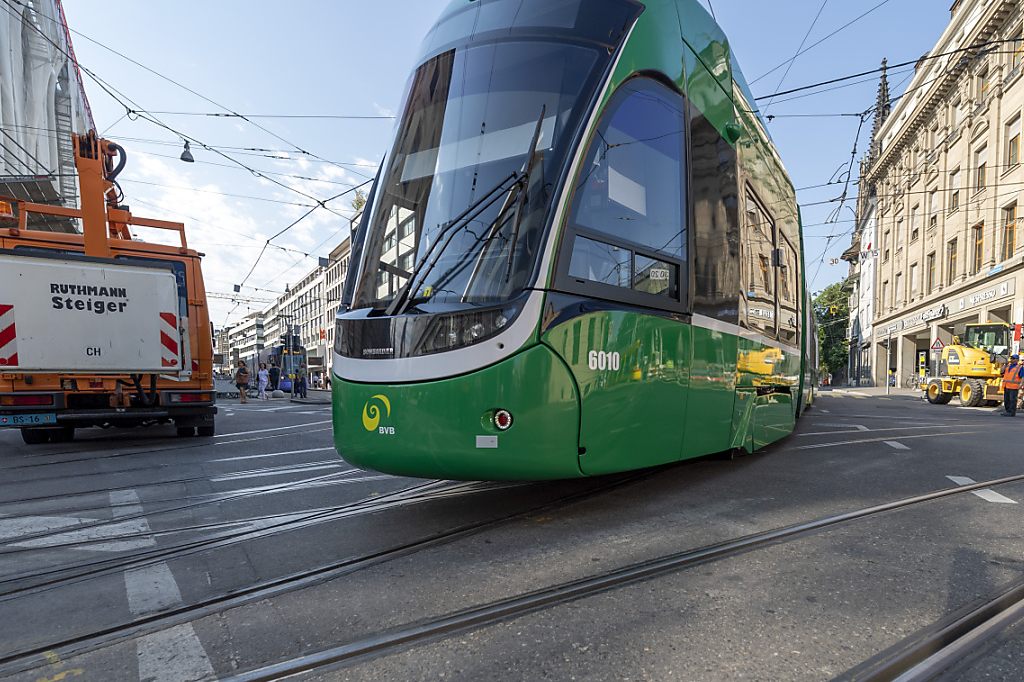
[922,323,1013,408]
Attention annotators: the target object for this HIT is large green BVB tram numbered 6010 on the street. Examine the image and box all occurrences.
[332,0,815,480]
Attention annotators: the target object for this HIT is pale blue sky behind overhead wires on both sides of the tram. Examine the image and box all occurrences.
[63,0,949,327]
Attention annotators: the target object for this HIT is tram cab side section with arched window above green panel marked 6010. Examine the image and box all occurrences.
[545,78,689,474]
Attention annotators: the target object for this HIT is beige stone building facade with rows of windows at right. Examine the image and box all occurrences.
[861,0,1024,385]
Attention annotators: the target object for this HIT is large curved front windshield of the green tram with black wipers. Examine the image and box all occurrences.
[352,0,627,314]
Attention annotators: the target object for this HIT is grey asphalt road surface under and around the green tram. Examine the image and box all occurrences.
[0,392,1024,682]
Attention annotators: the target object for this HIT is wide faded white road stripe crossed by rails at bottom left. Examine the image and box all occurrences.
[122,491,216,682]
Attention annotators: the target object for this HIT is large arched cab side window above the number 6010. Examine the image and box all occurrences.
[568,78,686,299]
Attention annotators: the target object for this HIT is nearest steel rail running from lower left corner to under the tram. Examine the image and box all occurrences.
[0,465,671,676]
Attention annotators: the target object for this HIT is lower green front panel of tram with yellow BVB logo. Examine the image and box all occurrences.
[332,345,583,480]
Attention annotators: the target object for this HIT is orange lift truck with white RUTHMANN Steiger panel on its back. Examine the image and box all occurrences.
[0,133,217,444]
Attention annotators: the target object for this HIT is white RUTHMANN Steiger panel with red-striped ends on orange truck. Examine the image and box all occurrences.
[0,255,182,375]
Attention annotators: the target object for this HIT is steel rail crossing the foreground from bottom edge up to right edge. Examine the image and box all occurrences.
[216,474,1024,682]
